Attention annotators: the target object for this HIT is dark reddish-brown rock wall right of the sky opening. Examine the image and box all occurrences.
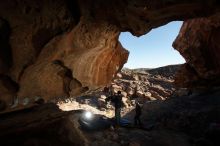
[173,15,220,87]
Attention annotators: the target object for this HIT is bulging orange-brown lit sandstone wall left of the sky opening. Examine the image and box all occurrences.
[18,19,128,99]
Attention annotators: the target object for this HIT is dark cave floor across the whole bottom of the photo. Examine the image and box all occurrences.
[0,91,220,146]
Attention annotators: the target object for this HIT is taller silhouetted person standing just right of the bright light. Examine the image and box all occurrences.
[106,91,122,126]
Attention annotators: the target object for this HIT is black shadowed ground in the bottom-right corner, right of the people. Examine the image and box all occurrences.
[123,90,220,146]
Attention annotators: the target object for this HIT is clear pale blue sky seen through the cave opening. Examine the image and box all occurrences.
[119,21,185,69]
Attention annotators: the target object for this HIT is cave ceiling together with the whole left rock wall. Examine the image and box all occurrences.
[0,0,220,110]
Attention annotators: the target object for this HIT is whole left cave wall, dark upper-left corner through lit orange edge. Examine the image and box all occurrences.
[0,1,128,108]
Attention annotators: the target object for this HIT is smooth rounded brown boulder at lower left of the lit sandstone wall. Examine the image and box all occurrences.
[18,62,69,100]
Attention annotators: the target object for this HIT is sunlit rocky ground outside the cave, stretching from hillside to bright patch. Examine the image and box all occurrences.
[69,65,180,112]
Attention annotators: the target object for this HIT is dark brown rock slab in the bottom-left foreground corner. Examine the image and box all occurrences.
[0,104,86,146]
